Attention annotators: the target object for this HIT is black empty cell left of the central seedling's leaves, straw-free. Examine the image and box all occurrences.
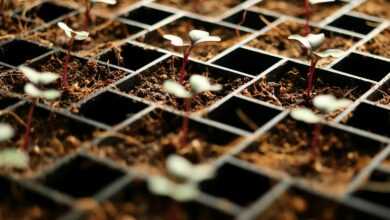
[80,92,147,125]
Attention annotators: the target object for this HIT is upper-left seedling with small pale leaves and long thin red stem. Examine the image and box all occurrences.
[57,22,89,89]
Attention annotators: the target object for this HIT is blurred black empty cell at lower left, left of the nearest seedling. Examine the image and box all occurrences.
[38,156,124,198]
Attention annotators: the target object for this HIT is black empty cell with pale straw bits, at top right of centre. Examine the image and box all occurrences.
[224,10,276,30]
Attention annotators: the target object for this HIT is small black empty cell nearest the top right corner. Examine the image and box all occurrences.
[329,15,379,34]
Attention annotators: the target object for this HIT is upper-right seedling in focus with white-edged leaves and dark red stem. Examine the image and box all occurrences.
[288,33,344,98]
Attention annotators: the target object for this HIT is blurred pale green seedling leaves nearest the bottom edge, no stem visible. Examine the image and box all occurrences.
[148,155,215,201]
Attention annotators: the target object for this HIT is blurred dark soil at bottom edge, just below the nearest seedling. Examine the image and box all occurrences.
[82,181,230,220]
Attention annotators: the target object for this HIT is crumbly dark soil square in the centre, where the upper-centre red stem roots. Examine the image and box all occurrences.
[128,57,249,111]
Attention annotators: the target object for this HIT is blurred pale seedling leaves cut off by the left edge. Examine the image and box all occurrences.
[0,123,29,169]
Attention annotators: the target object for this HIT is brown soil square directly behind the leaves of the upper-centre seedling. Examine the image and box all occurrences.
[137,18,245,61]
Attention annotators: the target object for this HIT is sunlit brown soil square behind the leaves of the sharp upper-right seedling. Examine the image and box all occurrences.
[248,21,357,67]
